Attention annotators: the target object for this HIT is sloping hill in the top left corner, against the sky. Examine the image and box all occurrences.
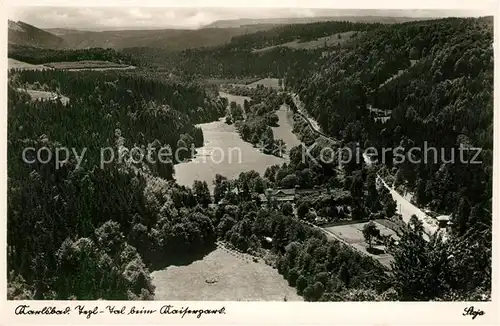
[8,20,66,49]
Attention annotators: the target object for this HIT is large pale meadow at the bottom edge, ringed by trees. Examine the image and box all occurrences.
[151,246,303,301]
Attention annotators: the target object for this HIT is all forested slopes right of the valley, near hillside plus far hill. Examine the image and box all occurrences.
[126,17,493,223]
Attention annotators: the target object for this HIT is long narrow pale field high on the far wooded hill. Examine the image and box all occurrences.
[253,31,363,52]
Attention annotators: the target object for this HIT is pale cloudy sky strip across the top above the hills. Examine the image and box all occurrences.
[9,7,484,30]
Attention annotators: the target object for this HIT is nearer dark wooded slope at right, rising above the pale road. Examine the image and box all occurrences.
[287,18,493,224]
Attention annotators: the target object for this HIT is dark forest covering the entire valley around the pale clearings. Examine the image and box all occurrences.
[7,17,493,301]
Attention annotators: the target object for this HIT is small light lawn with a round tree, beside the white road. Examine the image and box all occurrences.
[324,221,399,267]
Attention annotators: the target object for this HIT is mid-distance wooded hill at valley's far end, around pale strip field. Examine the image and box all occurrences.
[123,21,379,78]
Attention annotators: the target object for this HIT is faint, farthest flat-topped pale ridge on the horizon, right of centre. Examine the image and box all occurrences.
[203,16,429,28]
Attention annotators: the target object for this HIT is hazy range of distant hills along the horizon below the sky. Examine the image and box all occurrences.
[9,16,434,51]
